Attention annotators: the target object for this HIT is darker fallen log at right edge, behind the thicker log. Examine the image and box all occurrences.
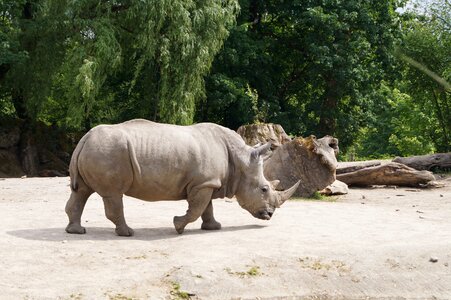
[393,152,451,171]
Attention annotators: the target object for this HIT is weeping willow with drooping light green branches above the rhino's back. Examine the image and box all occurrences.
[0,0,238,129]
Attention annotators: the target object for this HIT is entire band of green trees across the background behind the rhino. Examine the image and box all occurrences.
[0,0,451,158]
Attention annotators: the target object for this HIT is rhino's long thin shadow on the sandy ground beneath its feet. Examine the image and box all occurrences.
[6,224,266,242]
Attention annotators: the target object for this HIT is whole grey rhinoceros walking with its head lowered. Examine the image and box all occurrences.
[66,119,299,236]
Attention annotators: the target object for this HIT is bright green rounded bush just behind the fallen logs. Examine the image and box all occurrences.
[353,83,435,158]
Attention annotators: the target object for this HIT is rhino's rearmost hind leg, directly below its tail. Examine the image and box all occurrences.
[66,186,93,234]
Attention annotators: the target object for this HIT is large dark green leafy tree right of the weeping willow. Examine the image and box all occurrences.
[201,0,400,146]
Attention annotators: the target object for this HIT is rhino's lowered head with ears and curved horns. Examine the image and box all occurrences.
[235,143,300,220]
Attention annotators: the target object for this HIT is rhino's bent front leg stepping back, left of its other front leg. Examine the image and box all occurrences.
[174,188,213,233]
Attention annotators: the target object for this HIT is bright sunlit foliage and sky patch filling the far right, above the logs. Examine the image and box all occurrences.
[354,0,451,157]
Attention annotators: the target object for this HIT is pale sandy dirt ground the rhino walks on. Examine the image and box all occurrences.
[0,178,451,299]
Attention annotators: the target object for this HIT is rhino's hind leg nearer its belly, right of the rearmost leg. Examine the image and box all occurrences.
[103,195,134,236]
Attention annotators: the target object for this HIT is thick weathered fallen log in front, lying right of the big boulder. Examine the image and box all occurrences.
[337,162,435,187]
